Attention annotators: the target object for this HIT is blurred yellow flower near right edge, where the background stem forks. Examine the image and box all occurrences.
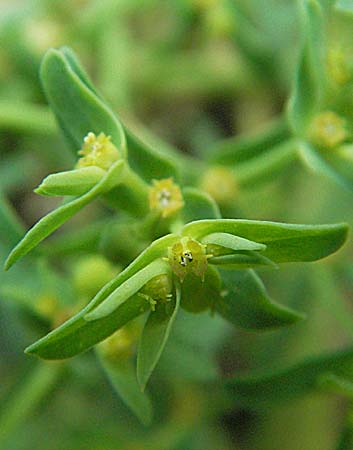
[309,111,348,148]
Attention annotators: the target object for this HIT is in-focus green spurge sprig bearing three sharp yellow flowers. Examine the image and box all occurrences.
[2,39,347,426]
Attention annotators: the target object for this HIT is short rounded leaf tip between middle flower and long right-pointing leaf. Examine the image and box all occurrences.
[182,188,221,223]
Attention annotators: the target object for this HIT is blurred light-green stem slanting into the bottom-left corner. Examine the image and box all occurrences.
[0,362,63,448]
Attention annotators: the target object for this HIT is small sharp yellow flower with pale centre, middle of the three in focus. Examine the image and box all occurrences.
[149,178,184,219]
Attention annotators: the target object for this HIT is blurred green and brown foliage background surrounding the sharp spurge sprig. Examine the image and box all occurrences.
[0,0,353,450]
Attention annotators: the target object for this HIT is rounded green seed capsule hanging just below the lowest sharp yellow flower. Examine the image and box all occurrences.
[181,266,222,313]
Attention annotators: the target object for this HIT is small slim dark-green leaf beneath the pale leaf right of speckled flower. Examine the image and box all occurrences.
[208,250,277,270]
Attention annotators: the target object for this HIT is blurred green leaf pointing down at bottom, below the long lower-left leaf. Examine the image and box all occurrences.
[97,351,152,425]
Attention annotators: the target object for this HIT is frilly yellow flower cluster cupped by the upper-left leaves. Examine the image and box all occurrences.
[76,132,120,170]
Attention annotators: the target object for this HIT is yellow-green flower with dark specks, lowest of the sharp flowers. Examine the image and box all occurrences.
[167,237,210,281]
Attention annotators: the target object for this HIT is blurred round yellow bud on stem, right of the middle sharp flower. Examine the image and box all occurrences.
[200,166,238,204]
